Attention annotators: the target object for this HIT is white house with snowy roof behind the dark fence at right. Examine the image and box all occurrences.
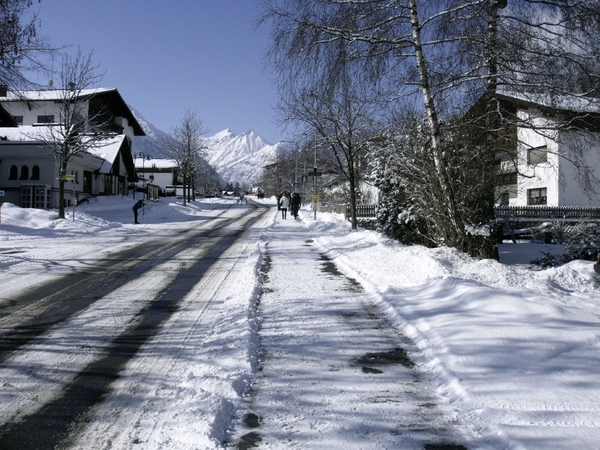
[496,95,600,206]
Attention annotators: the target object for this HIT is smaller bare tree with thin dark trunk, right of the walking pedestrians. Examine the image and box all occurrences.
[264,0,380,229]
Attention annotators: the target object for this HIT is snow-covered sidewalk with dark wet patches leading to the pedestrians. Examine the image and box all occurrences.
[236,213,462,450]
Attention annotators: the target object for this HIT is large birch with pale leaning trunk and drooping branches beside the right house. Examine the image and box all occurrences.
[265,0,599,257]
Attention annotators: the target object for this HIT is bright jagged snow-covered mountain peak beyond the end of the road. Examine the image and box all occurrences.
[205,129,281,186]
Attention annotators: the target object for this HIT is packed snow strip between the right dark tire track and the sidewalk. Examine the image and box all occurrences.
[59,207,270,450]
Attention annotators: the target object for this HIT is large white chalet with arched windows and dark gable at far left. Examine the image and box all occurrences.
[0,89,145,208]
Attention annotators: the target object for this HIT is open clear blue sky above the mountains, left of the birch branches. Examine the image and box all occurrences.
[36,0,284,143]
